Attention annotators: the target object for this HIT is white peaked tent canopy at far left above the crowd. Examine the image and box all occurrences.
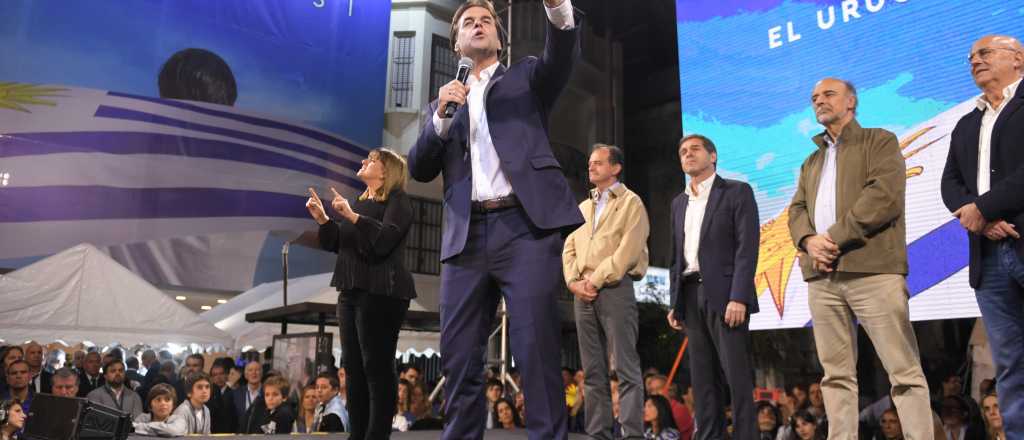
[0,244,231,347]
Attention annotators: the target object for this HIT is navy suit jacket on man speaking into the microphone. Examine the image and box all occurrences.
[409,14,584,261]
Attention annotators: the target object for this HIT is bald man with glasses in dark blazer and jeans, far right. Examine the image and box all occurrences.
[942,36,1024,438]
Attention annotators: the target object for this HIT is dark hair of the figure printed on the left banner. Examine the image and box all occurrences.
[157,48,239,105]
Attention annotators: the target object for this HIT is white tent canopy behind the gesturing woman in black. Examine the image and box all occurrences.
[200,273,439,355]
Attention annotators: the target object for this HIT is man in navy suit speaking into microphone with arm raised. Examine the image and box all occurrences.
[409,0,583,440]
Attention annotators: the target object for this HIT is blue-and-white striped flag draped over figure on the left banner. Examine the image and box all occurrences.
[0,83,368,259]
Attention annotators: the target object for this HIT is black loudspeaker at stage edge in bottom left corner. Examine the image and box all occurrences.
[24,394,133,440]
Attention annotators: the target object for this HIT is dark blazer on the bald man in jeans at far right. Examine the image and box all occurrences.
[942,84,1024,289]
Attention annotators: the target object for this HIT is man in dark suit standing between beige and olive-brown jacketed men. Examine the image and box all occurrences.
[668,134,761,440]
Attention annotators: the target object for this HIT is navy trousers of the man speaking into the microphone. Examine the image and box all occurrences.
[440,208,567,440]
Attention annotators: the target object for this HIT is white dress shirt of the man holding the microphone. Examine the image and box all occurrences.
[433,0,575,202]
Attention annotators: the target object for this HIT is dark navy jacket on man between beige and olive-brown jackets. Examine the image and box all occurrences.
[669,175,761,319]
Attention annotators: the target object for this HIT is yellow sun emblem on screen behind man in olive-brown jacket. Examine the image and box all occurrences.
[754,126,945,317]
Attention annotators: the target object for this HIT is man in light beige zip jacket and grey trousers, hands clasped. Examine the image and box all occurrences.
[562,143,650,440]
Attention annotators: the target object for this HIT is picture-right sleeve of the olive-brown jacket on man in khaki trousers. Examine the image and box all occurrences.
[828,132,906,252]
